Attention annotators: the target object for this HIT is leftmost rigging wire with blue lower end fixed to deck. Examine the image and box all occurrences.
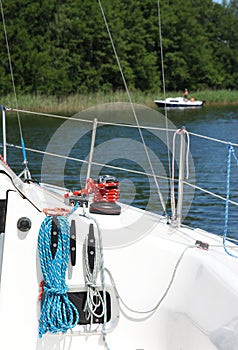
[0,0,31,178]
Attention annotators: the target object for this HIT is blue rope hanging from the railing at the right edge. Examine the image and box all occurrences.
[223,143,238,258]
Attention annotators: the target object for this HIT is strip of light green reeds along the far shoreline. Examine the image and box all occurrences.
[1,90,238,114]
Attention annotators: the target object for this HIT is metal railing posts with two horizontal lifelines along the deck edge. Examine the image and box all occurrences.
[1,109,238,232]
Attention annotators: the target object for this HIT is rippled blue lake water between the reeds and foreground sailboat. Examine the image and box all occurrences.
[1,106,238,239]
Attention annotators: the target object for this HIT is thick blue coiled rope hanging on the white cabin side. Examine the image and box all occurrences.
[38,212,79,338]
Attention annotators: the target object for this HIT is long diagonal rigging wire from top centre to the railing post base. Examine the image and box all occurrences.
[98,0,167,215]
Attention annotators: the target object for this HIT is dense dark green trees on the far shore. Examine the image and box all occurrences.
[0,0,238,96]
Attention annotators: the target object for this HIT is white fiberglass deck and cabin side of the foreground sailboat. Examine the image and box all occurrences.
[0,159,238,350]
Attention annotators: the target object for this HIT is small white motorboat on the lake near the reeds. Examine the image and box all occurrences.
[154,97,205,108]
